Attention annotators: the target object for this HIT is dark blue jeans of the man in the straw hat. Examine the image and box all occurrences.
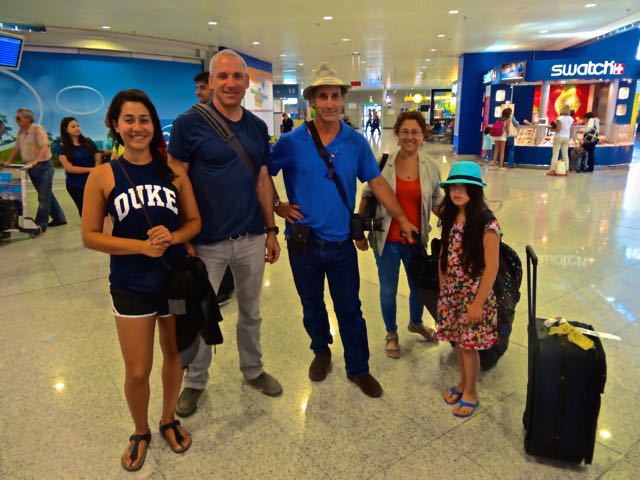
[289,235,369,376]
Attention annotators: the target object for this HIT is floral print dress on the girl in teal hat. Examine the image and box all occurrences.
[438,219,501,350]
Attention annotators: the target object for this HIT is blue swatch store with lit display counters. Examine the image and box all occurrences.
[458,29,640,168]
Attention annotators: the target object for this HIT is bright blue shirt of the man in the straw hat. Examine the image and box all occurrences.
[269,121,380,242]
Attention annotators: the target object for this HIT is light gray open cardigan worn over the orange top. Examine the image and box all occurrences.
[362,149,444,255]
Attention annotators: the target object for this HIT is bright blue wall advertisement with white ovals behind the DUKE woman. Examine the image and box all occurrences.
[0,51,203,157]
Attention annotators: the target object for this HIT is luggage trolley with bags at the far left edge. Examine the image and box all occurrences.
[0,165,42,239]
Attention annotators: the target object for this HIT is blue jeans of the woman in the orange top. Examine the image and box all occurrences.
[375,242,424,333]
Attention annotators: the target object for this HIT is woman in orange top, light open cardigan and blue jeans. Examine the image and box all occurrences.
[356,112,443,358]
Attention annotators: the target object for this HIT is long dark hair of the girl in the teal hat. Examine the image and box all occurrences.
[439,184,495,276]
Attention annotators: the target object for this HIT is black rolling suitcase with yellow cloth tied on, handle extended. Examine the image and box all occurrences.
[523,246,607,463]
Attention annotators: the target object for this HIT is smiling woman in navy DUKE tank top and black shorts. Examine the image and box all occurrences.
[82,90,200,471]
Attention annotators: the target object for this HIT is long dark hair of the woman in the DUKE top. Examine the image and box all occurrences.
[105,89,176,182]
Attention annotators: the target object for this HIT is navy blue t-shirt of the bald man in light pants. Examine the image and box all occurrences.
[168,104,269,244]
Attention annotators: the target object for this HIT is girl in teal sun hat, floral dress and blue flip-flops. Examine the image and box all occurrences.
[438,162,501,417]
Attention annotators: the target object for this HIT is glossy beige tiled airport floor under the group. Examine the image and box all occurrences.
[0,131,640,479]
